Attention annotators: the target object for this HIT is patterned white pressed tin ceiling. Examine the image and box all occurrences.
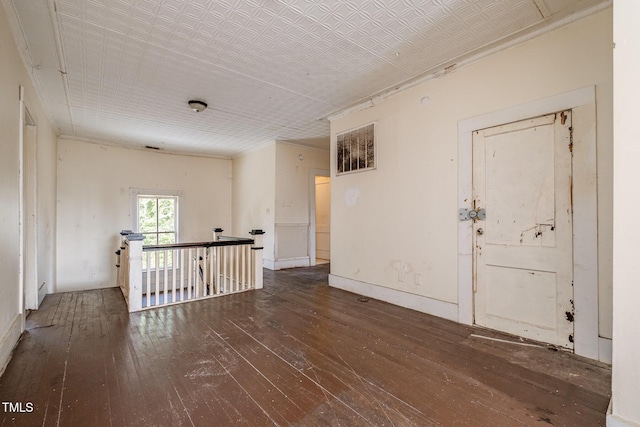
[3,0,610,157]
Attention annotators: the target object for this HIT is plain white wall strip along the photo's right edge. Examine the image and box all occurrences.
[607,0,640,427]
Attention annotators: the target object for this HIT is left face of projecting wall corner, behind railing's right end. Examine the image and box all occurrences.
[233,142,276,264]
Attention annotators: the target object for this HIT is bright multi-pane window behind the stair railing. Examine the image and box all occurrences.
[137,194,178,245]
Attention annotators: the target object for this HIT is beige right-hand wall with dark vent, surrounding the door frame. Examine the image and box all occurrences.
[331,10,613,337]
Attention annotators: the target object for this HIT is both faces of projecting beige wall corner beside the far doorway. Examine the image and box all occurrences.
[233,141,329,270]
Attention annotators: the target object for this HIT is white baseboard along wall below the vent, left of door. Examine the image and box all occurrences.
[329,274,458,323]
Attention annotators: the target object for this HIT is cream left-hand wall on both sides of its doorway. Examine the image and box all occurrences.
[0,1,56,371]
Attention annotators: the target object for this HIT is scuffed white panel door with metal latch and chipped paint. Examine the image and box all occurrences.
[473,111,573,348]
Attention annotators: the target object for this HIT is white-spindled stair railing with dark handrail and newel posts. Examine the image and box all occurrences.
[116,228,264,312]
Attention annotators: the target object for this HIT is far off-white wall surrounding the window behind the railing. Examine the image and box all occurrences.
[57,139,232,292]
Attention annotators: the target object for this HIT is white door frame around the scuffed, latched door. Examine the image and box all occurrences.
[458,86,600,360]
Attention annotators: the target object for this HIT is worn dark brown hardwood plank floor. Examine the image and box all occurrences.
[0,265,611,427]
